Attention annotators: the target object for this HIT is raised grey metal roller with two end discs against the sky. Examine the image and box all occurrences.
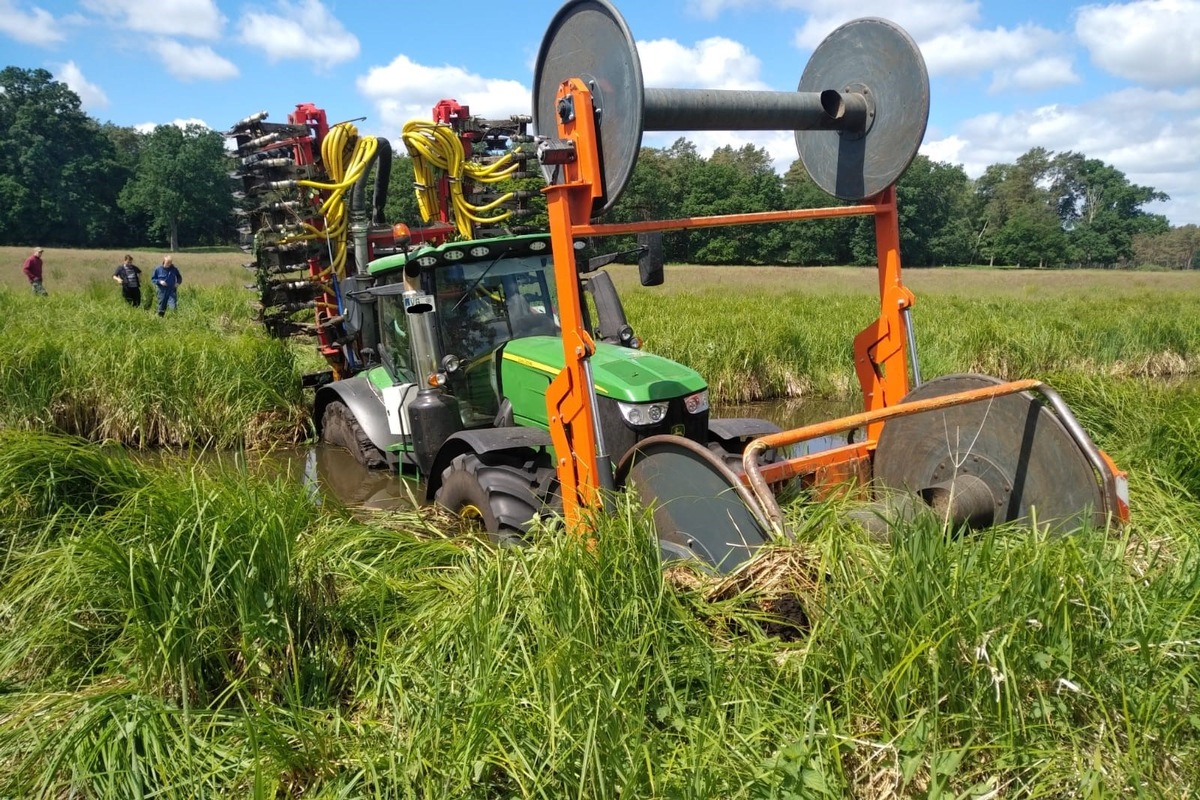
[533,0,929,216]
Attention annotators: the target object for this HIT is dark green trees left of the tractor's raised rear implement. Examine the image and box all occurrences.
[0,66,236,249]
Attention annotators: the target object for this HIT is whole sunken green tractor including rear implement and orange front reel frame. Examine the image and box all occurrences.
[230,0,1129,572]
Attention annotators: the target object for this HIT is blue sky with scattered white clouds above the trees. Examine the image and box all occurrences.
[0,0,1200,225]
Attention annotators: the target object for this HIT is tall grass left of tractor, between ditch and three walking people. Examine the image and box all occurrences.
[0,285,306,447]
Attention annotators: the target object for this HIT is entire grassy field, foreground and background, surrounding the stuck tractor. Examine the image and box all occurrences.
[0,248,1200,798]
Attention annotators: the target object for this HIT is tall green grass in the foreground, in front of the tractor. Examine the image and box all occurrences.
[0,424,1200,798]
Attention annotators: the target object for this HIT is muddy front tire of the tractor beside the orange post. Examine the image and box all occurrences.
[434,453,557,545]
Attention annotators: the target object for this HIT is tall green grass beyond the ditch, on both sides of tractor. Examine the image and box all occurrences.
[0,267,1200,447]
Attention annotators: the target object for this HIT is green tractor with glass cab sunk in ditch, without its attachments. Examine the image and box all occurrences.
[313,234,779,539]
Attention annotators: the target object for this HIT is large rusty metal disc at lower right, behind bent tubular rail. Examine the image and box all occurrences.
[875,374,1106,533]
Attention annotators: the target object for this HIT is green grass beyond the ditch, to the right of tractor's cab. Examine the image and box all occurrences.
[624,288,1200,403]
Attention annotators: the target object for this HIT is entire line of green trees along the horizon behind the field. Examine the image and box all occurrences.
[0,66,1200,269]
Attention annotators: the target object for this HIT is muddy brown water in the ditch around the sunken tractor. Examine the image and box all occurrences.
[146,401,859,511]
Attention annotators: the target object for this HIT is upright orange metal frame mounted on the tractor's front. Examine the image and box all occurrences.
[542,78,914,529]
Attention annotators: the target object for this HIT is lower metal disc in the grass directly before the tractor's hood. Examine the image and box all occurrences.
[617,435,768,573]
